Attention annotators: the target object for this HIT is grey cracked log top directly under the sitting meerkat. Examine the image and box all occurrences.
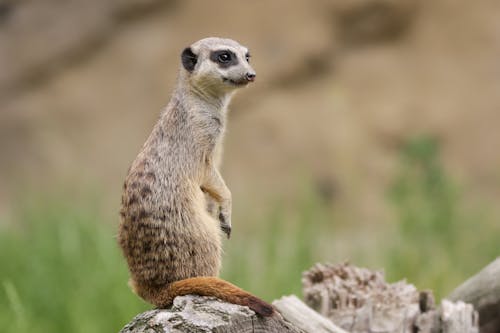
[120,295,303,333]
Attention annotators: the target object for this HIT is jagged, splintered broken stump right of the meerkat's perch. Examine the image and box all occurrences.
[302,264,478,333]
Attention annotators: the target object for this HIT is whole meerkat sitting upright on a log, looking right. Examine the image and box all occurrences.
[118,37,274,316]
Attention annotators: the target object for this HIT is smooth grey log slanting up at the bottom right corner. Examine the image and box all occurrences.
[448,257,500,333]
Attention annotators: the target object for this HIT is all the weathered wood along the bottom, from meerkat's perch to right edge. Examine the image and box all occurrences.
[120,258,500,333]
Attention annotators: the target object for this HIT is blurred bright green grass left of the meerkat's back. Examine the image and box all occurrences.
[0,200,147,332]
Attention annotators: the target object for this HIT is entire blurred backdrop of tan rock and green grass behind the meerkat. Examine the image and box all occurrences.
[0,0,500,332]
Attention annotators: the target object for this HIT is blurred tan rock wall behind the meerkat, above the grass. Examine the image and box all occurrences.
[0,0,500,223]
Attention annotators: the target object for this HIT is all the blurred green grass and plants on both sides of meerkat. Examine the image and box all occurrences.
[0,137,500,333]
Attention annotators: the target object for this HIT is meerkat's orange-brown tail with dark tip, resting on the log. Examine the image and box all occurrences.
[133,277,274,317]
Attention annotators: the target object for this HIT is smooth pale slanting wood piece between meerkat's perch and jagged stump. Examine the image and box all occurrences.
[273,295,348,333]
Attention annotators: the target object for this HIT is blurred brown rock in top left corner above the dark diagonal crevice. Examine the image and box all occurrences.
[0,0,173,98]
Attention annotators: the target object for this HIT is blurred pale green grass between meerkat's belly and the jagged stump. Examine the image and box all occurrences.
[222,191,329,301]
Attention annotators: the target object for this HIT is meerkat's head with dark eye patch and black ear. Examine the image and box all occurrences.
[181,37,256,95]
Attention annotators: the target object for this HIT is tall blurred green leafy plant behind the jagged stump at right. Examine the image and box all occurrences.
[385,136,500,298]
